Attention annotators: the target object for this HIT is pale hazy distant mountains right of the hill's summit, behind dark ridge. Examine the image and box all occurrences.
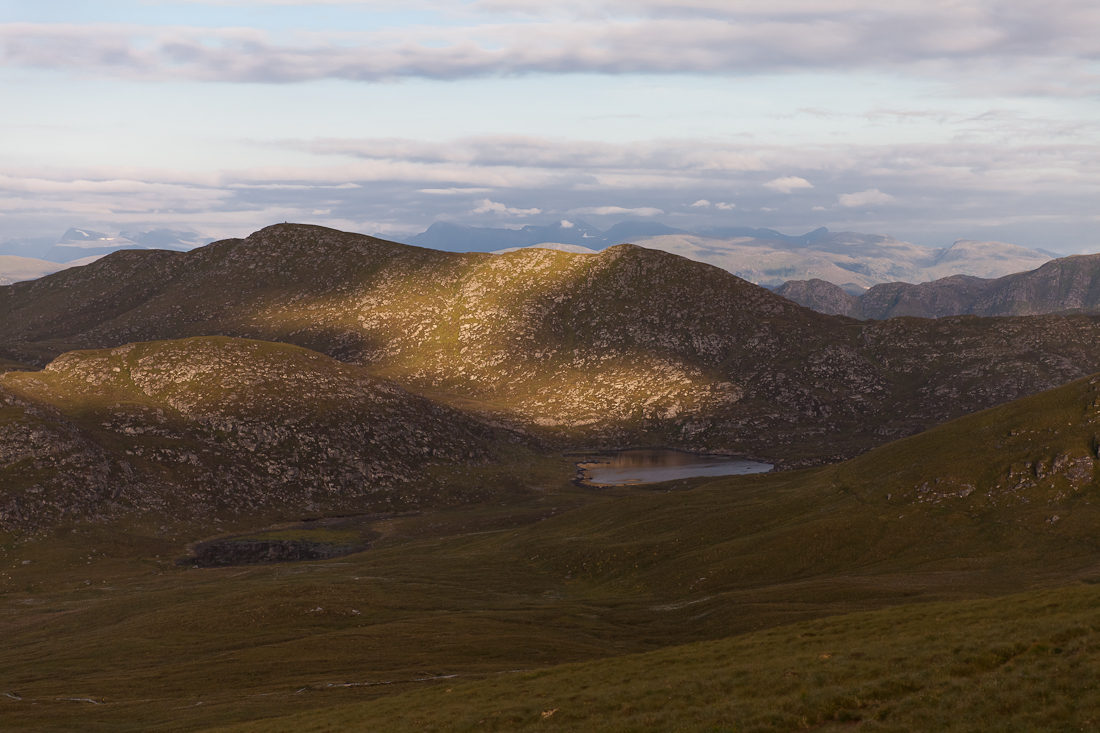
[634,230,1049,288]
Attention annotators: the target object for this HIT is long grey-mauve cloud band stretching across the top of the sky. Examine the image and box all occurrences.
[0,0,1100,91]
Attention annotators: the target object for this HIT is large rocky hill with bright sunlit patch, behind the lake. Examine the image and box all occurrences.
[0,225,1100,466]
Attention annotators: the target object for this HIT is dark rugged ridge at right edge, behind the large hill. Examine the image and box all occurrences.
[776,254,1100,319]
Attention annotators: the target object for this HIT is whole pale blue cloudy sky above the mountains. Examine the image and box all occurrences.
[0,0,1100,252]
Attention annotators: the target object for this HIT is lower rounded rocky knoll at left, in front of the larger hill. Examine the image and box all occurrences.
[0,337,509,530]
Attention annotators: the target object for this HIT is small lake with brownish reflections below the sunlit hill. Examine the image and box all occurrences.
[576,448,772,485]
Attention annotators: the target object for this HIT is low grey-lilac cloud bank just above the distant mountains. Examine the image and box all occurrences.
[0,136,1100,251]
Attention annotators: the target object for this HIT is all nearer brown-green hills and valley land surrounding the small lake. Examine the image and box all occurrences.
[0,225,1100,733]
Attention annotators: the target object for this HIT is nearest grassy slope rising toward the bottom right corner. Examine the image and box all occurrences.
[206,586,1100,733]
